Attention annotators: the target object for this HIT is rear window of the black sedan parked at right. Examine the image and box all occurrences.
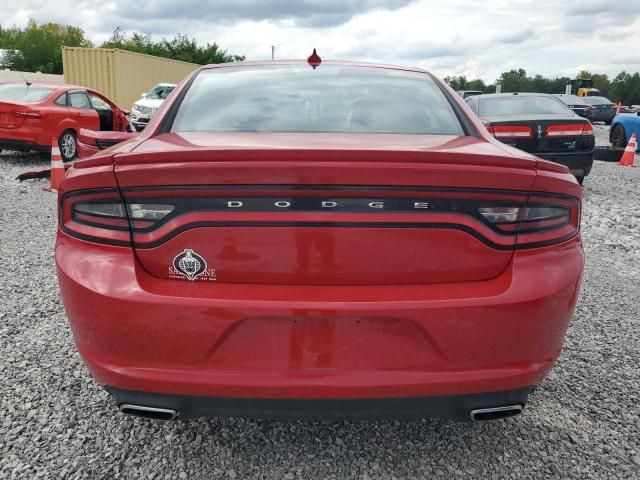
[480,95,573,117]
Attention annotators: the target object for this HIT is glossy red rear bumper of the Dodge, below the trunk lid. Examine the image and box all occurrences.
[56,233,584,414]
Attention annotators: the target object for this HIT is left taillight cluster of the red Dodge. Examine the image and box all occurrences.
[59,188,174,246]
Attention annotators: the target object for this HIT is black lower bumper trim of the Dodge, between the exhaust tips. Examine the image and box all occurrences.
[107,387,534,420]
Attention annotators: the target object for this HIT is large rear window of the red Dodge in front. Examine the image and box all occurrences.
[172,65,463,135]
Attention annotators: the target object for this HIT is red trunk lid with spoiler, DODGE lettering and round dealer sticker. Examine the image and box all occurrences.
[115,133,536,285]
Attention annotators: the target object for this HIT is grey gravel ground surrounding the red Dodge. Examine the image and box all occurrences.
[0,127,640,479]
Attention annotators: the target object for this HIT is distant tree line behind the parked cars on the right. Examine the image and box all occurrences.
[444,68,640,105]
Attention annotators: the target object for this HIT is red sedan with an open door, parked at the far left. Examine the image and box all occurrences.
[0,82,129,161]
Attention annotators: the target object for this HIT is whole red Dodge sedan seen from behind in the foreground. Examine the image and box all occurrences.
[55,59,584,420]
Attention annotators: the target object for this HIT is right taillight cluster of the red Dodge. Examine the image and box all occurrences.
[478,194,580,248]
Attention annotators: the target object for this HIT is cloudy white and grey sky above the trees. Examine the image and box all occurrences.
[0,0,640,82]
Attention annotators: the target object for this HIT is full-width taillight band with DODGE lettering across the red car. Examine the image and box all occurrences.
[60,186,580,250]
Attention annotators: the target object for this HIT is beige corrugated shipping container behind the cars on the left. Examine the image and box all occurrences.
[62,47,200,110]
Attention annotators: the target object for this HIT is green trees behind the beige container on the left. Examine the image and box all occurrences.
[0,20,245,74]
